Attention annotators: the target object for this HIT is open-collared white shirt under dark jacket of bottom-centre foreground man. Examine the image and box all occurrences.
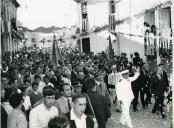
[70,109,86,128]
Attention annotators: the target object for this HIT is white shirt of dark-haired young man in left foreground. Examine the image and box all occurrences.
[29,103,58,128]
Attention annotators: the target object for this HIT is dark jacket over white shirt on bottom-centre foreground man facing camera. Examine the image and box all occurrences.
[66,112,94,128]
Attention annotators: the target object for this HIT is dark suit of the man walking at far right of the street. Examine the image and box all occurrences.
[151,75,167,116]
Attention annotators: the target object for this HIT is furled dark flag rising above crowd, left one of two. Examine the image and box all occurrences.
[50,35,62,66]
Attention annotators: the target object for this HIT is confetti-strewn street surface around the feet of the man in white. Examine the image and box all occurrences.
[98,75,172,128]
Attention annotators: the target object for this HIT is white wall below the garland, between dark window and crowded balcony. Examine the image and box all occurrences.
[117,15,145,60]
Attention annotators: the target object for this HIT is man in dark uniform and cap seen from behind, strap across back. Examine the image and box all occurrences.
[85,77,111,128]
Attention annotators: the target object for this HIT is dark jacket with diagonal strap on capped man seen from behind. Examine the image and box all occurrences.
[85,91,111,128]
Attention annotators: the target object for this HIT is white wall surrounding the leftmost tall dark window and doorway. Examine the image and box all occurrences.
[77,2,109,54]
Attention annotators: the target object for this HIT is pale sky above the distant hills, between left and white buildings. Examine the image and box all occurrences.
[17,0,77,29]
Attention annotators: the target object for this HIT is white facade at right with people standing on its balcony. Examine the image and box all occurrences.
[115,0,172,72]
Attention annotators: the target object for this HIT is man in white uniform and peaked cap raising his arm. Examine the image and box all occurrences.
[116,68,140,128]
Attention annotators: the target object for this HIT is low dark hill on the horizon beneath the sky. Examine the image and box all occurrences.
[33,26,62,33]
